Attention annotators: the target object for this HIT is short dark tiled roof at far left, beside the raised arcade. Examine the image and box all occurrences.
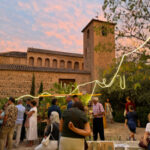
[0,51,27,58]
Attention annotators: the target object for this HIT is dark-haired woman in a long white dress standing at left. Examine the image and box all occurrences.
[26,101,38,147]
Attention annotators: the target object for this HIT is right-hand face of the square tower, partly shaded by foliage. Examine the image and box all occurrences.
[92,22,115,79]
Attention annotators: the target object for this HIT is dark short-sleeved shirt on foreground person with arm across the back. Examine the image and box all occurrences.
[62,108,88,138]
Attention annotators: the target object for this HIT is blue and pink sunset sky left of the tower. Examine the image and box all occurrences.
[0,0,105,53]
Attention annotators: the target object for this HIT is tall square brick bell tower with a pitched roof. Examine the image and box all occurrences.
[82,19,115,80]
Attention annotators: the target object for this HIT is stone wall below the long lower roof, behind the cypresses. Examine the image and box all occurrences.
[0,70,90,97]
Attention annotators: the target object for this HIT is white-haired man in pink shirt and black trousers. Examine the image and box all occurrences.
[92,97,105,141]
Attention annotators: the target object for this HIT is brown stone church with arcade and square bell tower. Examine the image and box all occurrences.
[0,19,115,97]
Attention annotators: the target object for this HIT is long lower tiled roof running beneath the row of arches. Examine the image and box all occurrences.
[0,64,90,74]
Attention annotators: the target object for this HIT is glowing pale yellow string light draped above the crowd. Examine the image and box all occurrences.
[16,37,150,100]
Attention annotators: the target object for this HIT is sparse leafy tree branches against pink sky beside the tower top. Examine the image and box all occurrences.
[103,0,150,55]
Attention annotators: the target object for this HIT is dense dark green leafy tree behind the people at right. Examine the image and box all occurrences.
[98,53,150,127]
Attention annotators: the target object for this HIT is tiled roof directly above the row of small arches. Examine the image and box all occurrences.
[28,48,83,58]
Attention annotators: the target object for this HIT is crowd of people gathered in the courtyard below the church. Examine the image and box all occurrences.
[0,95,150,150]
